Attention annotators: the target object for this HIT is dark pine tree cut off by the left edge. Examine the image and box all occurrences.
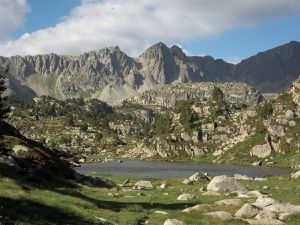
[0,67,10,121]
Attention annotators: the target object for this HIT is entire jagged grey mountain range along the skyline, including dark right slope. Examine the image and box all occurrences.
[0,41,300,104]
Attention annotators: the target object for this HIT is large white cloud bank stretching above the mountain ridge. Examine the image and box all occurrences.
[0,0,300,56]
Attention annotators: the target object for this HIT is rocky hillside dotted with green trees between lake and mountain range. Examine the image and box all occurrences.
[4,75,300,167]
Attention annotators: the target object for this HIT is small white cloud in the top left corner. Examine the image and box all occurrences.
[0,0,30,41]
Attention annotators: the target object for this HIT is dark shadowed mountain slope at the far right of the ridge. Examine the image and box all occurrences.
[234,41,300,92]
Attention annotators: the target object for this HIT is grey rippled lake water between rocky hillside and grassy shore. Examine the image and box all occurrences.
[76,160,292,179]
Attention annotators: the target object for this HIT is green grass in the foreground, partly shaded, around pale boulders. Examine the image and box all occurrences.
[0,175,300,225]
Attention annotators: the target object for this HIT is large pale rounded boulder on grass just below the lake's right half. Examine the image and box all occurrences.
[207,175,246,192]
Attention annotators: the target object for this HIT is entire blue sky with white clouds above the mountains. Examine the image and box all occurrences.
[0,0,300,63]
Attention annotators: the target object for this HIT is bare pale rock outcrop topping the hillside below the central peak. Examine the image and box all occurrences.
[128,82,264,108]
